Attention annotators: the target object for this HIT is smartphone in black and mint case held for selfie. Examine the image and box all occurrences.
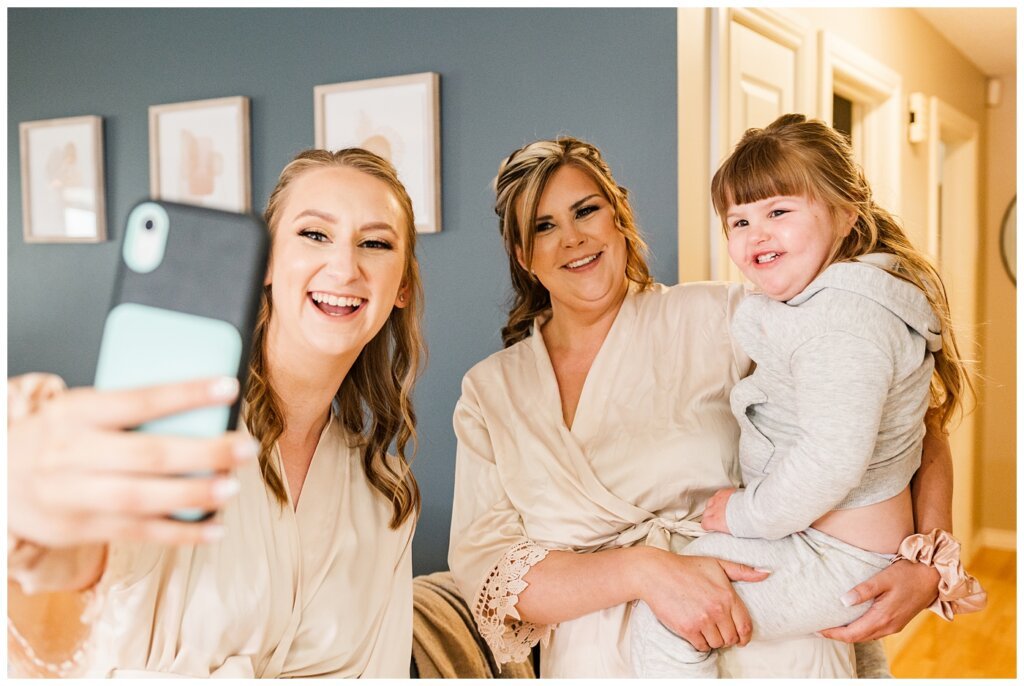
[95,201,269,521]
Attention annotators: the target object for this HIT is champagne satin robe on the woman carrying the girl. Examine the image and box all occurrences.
[449,284,854,677]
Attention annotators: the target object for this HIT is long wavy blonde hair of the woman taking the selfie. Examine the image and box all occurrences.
[245,147,425,528]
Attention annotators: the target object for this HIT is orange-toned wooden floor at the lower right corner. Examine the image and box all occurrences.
[890,548,1017,679]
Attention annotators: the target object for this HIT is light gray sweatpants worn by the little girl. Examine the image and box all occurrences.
[630,528,892,679]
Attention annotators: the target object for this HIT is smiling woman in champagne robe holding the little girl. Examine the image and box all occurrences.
[450,122,974,677]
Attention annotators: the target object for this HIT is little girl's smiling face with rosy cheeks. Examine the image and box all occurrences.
[726,196,856,301]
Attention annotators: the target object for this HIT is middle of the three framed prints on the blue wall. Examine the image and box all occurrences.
[150,96,252,212]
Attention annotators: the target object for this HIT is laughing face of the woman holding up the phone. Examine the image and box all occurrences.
[267,167,408,357]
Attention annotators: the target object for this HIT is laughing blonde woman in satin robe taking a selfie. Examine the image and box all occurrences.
[8,148,422,678]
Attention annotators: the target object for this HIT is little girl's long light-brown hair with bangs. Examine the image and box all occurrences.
[711,115,973,429]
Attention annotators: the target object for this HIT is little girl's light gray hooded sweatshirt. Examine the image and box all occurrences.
[726,253,942,540]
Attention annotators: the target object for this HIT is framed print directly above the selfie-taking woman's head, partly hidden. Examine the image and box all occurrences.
[313,72,441,233]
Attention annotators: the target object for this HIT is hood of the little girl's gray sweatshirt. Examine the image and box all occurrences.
[786,253,942,352]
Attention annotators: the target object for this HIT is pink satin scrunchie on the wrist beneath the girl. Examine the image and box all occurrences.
[893,528,988,620]
